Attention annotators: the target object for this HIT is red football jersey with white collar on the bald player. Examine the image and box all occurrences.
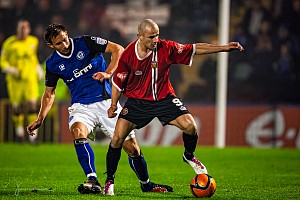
[112,39,195,101]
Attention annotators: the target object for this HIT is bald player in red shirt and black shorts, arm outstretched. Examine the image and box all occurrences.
[101,19,244,194]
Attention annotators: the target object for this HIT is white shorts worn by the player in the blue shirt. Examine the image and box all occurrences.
[68,99,135,140]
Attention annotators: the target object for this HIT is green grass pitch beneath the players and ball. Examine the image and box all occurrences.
[0,144,300,200]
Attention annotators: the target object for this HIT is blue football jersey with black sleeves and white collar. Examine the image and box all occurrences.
[45,36,111,104]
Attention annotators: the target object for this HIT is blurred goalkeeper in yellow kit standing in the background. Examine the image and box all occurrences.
[0,19,44,142]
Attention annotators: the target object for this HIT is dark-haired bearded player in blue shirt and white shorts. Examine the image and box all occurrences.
[27,24,173,195]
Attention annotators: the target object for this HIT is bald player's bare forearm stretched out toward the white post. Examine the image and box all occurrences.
[196,42,244,55]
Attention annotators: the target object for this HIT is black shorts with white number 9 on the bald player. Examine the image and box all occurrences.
[119,95,190,129]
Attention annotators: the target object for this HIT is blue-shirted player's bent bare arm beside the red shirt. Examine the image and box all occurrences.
[93,41,124,82]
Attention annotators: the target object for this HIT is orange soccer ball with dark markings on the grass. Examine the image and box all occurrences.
[190,174,217,198]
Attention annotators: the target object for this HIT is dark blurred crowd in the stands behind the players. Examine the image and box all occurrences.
[0,0,300,104]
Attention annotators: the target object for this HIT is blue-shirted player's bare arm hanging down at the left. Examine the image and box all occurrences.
[26,87,56,135]
